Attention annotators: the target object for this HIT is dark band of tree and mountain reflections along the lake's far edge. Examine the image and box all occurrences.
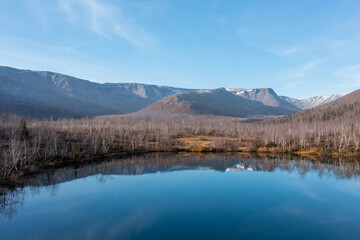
[0,154,360,219]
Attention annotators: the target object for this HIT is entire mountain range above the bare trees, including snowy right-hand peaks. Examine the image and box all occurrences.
[0,66,342,118]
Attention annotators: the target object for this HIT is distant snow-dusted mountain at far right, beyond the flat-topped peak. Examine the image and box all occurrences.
[281,93,347,110]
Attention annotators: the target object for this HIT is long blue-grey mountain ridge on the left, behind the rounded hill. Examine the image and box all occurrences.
[0,67,195,117]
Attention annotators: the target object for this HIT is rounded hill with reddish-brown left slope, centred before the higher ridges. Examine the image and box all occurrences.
[136,88,299,118]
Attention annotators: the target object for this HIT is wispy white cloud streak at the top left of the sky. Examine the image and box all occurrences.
[59,0,155,48]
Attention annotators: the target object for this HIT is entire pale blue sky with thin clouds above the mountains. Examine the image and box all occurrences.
[0,0,360,98]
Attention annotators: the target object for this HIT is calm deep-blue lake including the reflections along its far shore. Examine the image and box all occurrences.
[0,155,360,239]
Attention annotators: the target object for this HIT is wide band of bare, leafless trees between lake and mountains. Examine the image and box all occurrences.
[0,107,360,178]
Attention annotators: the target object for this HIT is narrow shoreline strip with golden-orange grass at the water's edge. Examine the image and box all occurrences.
[0,135,360,187]
